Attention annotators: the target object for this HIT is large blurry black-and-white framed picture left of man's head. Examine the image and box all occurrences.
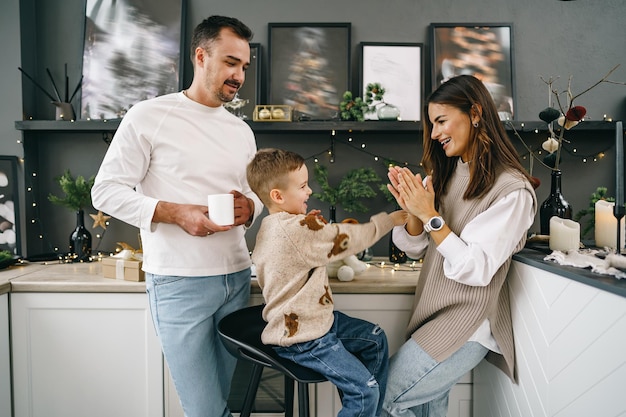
[80,0,188,120]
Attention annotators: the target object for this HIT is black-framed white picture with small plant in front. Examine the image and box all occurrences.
[359,42,424,121]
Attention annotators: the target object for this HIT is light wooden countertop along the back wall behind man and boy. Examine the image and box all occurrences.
[0,261,421,294]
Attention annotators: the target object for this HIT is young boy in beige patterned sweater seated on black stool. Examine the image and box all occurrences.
[247,149,406,417]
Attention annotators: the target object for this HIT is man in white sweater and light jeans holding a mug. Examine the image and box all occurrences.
[92,16,262,417]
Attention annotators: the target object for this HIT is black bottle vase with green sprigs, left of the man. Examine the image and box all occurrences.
[48,169,95,262]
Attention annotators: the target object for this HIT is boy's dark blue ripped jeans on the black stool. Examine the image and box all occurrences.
[274,311,389,417]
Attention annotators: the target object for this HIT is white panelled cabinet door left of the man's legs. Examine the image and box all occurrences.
[11,293,163,417]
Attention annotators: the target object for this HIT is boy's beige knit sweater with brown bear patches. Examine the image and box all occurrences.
[252,212,393,346]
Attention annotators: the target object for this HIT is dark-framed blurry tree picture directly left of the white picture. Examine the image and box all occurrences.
[267,23,352,120]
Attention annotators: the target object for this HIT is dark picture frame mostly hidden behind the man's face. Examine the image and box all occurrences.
[224,43,263,120]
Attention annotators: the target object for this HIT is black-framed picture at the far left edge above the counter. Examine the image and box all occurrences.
[0,155,22,256]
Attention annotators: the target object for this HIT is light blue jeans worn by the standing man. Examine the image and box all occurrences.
[146,269,250,417]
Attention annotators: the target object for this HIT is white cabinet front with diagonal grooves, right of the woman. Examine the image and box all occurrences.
[474,261,626,417]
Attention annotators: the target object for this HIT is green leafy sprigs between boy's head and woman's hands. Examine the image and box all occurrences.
[313,164,381,213]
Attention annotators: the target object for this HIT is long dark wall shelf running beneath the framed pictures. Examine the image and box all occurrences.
[15,119,615,133]
